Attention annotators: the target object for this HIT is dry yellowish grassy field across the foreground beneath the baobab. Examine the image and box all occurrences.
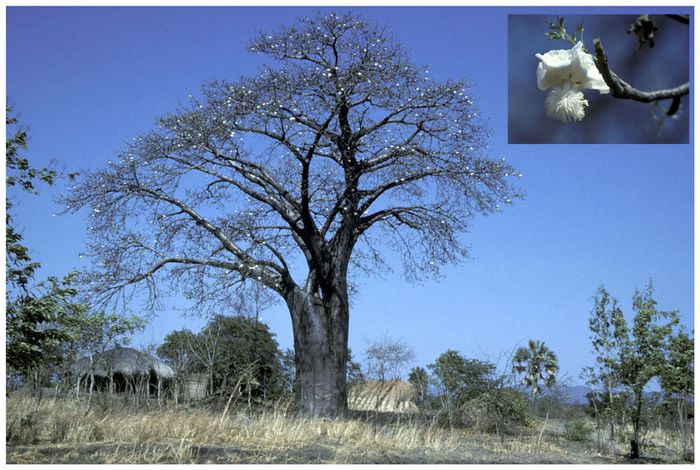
[7,396,692,464]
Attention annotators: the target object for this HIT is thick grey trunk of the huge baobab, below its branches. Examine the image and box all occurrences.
[287,282,349,418]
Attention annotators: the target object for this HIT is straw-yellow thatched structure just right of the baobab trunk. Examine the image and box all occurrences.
[348,380,418,413]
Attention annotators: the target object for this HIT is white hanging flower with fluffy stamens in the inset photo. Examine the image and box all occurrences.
[535,41,610,122]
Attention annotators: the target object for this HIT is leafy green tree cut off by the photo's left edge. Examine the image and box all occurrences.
[5,107,86,396]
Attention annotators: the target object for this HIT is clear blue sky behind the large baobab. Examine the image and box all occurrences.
[6,7,694,382]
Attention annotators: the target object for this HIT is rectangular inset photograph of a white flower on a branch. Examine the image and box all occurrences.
[508,12,692,144]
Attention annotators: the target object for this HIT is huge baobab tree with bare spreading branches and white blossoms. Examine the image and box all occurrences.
[66,13,518,416]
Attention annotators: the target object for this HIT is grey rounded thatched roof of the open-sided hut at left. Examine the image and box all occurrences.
[71,348,175,379]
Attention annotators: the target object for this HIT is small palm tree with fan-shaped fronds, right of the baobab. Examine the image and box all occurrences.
[513,339,559,402]
